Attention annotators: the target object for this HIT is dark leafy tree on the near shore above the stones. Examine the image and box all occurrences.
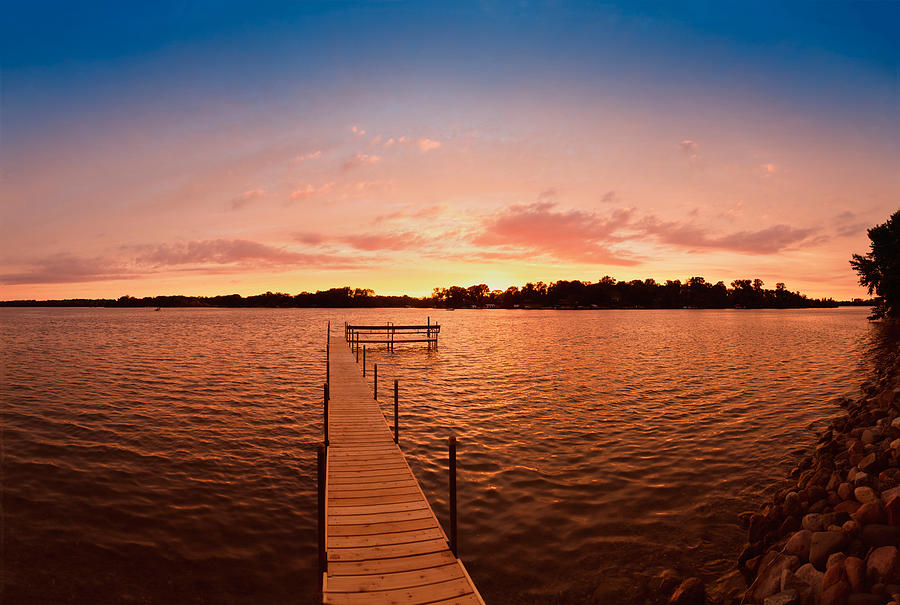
[850,210,900,319]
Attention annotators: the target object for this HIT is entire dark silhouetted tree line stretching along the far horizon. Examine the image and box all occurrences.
[0,276,856,309]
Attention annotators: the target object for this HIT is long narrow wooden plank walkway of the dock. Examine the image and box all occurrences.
[322,334,484,605]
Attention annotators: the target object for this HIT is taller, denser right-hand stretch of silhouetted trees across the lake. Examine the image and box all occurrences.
[431,276,840,309]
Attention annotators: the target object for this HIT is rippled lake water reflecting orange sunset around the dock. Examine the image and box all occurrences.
[0,308,872,604]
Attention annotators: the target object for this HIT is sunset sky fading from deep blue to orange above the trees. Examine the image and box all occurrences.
[0,1,900,300]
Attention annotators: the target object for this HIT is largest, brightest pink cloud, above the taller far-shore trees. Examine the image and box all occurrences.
[472,202,640,266]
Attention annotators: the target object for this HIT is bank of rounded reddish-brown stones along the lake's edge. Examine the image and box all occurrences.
[653,336,900,605]
